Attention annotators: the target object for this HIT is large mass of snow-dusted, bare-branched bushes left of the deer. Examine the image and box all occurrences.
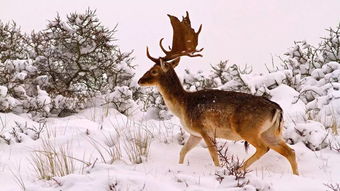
[0,10,134,118]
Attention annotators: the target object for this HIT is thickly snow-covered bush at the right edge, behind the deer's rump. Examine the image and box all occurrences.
[276,25,340,132]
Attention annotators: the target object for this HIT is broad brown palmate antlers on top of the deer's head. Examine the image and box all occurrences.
[146,12,203,64]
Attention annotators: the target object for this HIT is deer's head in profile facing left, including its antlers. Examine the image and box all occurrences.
[138,12,203,86]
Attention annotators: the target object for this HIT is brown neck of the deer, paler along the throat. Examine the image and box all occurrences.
[158,69,187,117]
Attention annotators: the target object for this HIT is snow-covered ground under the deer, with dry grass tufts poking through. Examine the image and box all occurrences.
[0,105,340,191]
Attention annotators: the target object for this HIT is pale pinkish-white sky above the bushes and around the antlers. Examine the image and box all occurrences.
[0,0,340,75]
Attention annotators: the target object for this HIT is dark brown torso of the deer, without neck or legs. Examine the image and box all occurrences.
[185,90,282,138]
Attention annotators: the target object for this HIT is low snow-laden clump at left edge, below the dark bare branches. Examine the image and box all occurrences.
[0,59,51,113]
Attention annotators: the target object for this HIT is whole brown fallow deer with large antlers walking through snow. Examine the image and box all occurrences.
[138,12,299,175]
